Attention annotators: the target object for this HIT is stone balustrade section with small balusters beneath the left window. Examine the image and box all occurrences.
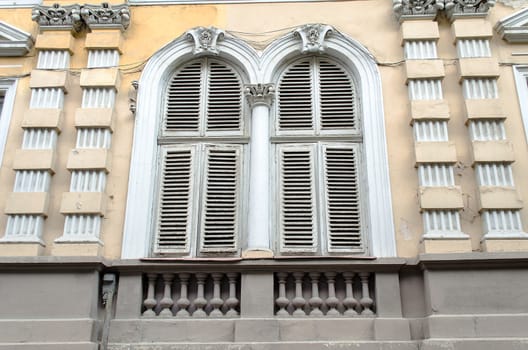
[142,272,240,318]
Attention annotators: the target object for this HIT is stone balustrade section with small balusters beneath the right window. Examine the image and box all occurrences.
[275,272,375,317]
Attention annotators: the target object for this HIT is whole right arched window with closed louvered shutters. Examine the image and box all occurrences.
[272,56,366,255]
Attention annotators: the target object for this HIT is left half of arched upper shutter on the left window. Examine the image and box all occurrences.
[164,61,203,133]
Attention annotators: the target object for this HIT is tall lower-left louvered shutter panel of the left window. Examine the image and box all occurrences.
[155,146,195,253]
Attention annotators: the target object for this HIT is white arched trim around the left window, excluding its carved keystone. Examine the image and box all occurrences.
[121,31,259,259]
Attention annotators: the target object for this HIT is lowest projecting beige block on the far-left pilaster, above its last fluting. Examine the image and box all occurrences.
[5,192,49,216]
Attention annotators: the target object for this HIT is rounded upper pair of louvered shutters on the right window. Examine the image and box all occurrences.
[276,56,359,135]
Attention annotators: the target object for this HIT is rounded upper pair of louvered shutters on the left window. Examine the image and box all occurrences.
[163,58,244,136]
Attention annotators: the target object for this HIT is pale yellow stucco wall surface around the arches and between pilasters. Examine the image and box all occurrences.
[0,0,528,258]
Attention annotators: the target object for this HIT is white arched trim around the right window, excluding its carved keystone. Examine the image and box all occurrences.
[262,30,396,257]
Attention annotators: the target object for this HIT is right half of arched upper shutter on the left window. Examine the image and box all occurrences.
[207,61,242,133]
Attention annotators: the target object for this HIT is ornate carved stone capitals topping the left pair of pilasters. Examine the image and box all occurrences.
[31,2,130,32]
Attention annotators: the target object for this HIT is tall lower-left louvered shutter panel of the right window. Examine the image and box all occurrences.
[278,145,318,253]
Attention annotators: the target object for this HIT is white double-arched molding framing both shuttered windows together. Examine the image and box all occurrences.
[121,26,396,259]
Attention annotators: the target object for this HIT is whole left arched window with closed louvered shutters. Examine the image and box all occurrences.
[154,57,247,255]
